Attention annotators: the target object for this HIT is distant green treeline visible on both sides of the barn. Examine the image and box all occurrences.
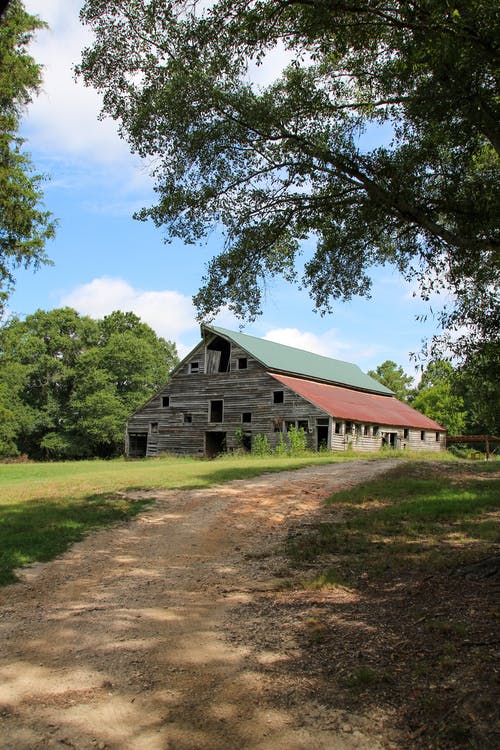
[0,307,500,460]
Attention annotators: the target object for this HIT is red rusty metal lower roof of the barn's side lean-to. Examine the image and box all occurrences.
[269,372,445,430]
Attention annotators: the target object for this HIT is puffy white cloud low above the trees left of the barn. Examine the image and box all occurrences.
[60,277,198,356]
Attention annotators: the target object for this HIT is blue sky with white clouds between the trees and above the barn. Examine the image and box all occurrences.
[9,0,442,374]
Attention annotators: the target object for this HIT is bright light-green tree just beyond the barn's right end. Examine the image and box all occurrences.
[412,360,467,435]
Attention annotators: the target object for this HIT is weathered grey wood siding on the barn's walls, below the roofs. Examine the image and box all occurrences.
[126,343,443,456]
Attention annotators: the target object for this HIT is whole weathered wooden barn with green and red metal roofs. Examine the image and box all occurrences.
[126,325,446,458]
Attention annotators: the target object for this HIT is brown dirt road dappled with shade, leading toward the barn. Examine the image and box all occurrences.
[0,460,395,750]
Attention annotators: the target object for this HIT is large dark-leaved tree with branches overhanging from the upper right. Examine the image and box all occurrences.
[78,0,500,358]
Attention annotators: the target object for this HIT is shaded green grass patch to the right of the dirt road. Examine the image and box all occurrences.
[288,464,500,588]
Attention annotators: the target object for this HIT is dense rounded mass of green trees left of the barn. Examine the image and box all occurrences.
[0,308,178,458]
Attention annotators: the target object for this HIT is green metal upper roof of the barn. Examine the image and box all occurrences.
[201,325,393,396]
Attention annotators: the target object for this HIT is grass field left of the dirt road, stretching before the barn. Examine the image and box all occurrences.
[0,452,492,585]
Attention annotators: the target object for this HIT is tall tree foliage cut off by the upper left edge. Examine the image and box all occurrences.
[0,0,55,313]
